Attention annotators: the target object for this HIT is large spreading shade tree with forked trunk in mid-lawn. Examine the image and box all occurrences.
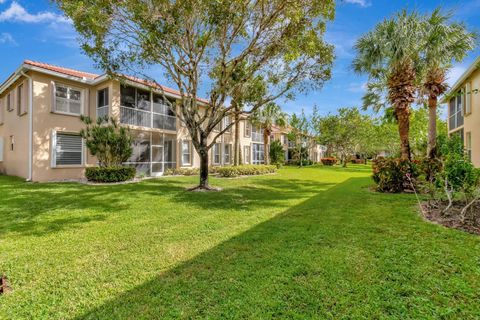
[56,0,335,189]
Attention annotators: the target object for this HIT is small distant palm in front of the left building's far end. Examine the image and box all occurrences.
[252,102,288,164]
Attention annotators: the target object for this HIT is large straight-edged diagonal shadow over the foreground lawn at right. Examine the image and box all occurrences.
[77,178,475,319]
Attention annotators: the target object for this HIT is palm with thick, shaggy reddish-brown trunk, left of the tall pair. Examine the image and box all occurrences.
[353,10,422,159]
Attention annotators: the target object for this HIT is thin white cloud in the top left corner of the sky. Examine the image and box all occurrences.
[0,0,69,23]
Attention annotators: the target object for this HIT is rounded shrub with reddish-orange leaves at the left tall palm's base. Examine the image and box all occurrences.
[373,158,419,193]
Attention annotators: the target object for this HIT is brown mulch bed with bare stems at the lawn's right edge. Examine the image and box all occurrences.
[422,202,480,235]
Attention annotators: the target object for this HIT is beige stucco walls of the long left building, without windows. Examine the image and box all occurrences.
[0,71,274,182]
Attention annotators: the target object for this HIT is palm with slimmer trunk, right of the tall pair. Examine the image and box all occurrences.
[420,9,476,159]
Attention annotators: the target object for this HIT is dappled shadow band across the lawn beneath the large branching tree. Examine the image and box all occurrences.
[0,177,326,237]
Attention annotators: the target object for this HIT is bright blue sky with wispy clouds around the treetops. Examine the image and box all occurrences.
[0,0,480,114]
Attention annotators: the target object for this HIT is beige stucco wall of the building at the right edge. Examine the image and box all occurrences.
[447,69,480,167]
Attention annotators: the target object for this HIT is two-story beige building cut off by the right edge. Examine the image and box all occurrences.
[442,57,480,167]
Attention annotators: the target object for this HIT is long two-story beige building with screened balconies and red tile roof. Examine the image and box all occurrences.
[0,60,265,181]
